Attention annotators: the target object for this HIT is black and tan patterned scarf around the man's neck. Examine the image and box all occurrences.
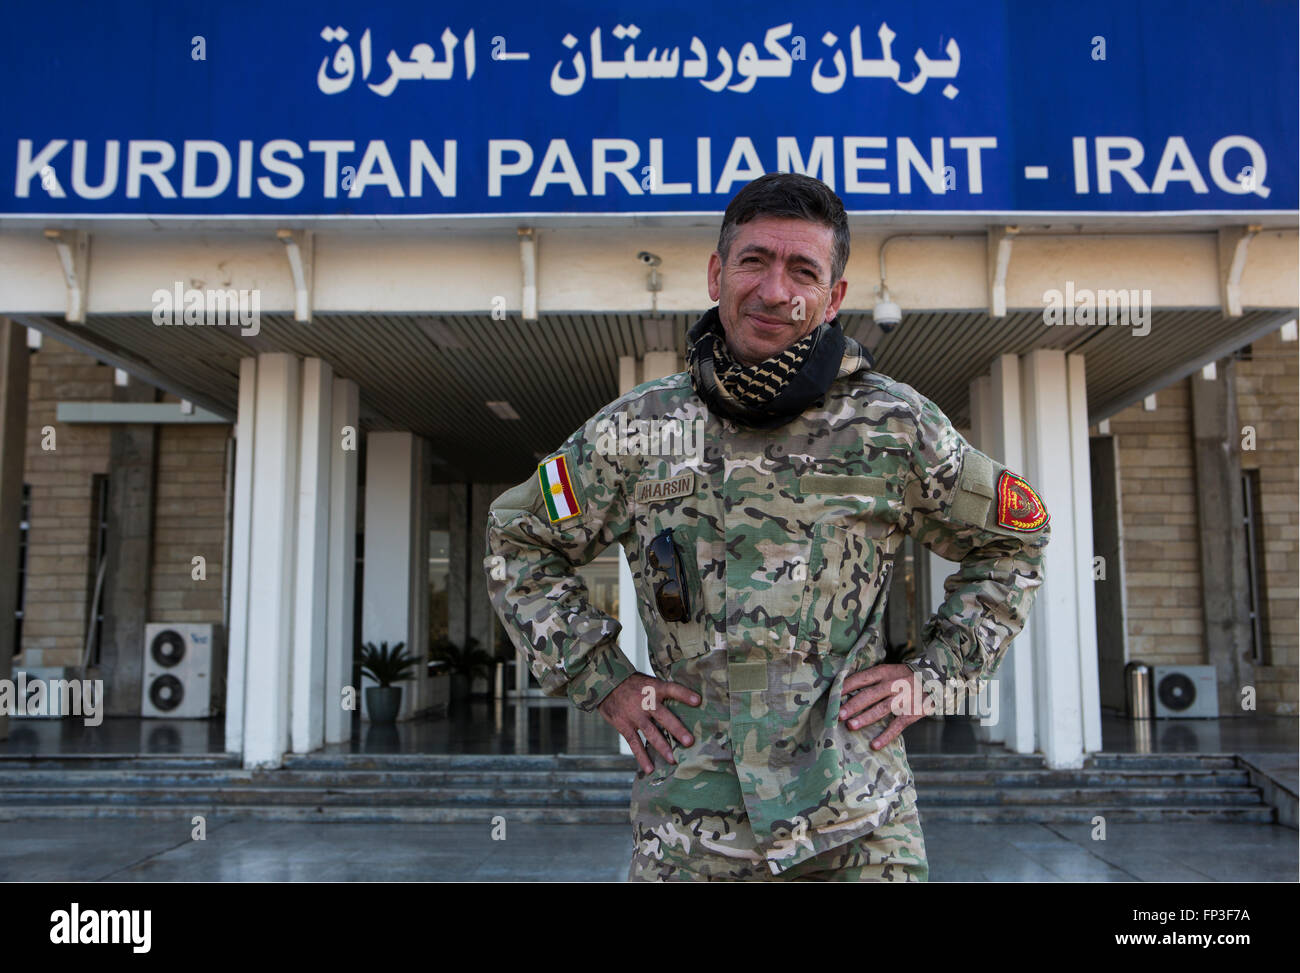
[686,307,874,429]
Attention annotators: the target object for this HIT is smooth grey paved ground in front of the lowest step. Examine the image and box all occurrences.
[0,818,1297,882]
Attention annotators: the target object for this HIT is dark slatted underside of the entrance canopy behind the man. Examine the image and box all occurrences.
[18,308,1294,483]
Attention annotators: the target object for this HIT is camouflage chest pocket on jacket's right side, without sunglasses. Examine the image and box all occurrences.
[798,522,892,654]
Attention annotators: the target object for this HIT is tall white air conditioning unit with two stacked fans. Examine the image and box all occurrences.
[140,622,225,719]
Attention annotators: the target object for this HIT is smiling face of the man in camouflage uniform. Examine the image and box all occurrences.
[709,216,849,364]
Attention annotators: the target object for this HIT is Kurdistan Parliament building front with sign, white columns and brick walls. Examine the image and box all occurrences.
[0,3,1297,766]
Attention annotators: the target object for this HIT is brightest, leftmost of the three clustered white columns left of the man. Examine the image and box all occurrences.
[243,354,302,767]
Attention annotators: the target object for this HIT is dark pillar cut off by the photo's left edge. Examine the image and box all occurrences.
[0,317,30,740]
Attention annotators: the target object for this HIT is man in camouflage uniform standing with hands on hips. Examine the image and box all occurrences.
[485,174,1049,881]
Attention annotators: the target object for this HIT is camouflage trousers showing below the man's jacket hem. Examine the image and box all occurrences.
[628,803,930,882]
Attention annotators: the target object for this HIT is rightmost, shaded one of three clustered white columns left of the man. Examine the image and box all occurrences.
[321,379,360,743]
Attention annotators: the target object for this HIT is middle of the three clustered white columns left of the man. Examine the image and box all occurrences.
[290,358,334,753]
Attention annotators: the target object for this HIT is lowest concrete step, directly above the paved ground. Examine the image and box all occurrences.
[0,804,1274,827]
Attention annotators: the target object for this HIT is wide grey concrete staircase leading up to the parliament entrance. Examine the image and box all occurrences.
[0,753,1275,823]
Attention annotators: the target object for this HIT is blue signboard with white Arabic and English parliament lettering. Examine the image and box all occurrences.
[0,0,1300,217]
